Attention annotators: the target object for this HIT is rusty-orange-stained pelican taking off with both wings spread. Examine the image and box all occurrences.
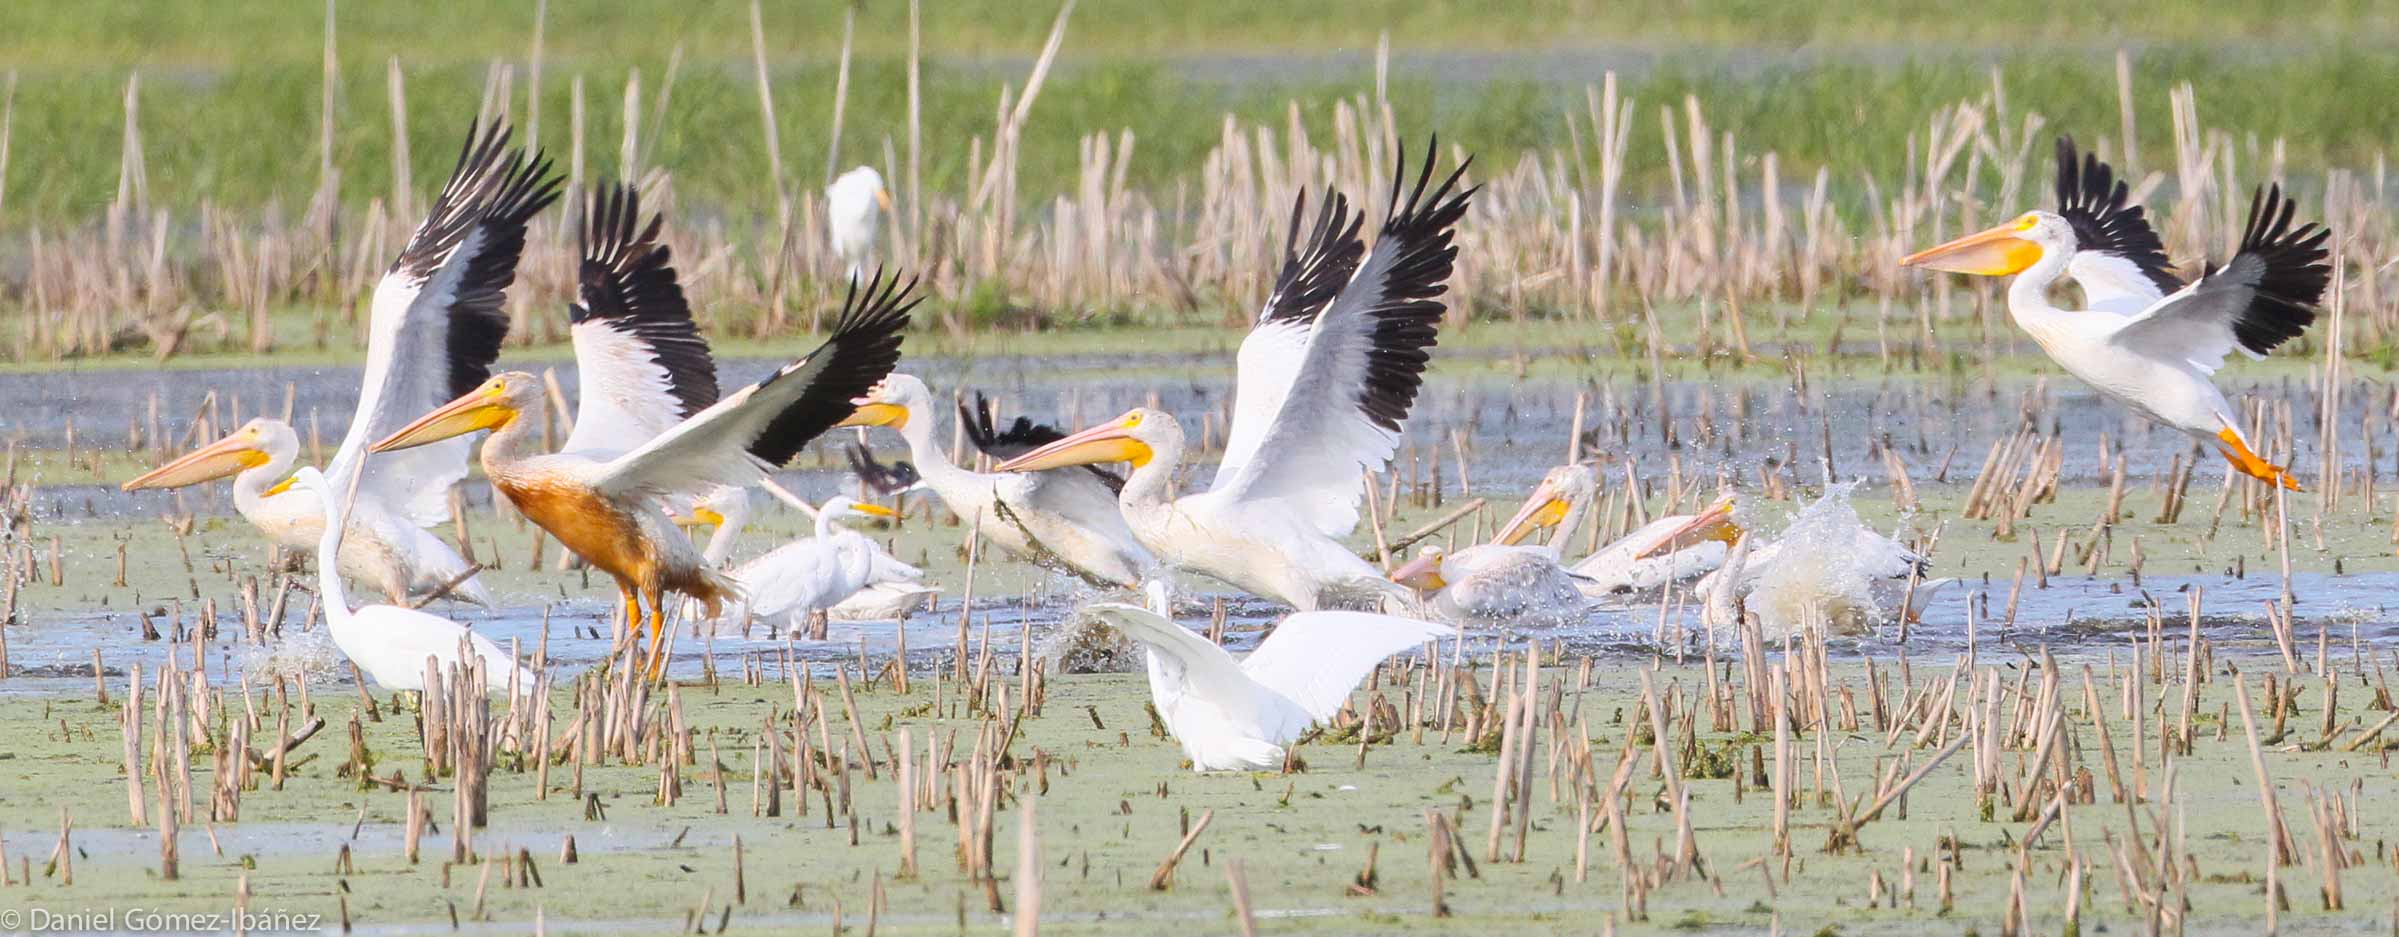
[374,187,916,676]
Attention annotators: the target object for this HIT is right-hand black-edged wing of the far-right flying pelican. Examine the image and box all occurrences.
[2109,185,2332,374]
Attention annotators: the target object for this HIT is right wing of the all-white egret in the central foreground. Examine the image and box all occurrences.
[1247,611,1459,721]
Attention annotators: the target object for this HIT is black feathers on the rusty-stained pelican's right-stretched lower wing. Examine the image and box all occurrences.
[748,271,924,465]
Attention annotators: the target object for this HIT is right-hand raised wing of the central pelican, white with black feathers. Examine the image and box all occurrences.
[1209,149,1475,537]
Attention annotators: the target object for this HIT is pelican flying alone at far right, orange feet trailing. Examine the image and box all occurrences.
[1900,139,2332,491]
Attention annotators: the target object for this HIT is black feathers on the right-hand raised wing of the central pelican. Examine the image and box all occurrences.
[1358,137,1483,431]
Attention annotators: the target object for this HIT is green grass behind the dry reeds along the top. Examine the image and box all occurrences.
[0,0,2399,224]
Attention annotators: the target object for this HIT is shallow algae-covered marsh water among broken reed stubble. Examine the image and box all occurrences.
[0,355,2399,935]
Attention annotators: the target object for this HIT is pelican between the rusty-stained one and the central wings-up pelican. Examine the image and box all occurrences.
[842,374,1156,590]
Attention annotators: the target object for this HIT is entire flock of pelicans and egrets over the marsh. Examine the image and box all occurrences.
[107,125,2327,769]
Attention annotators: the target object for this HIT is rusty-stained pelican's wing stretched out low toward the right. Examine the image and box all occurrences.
[599,278,916,496]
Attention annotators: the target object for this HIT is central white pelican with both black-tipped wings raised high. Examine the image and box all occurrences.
[998,137,1475,611]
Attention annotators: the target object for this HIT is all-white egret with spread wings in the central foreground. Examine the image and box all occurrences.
[1082,582,1459,772]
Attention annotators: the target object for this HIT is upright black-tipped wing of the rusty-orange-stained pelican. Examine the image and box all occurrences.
[561,185,717,458]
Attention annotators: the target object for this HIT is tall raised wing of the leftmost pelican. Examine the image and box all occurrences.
[329,122,559,527]
